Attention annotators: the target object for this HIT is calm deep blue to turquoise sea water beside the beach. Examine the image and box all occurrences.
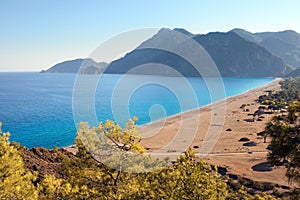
[0,73,274,148]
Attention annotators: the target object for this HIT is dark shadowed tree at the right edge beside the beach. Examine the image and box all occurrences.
[258,77,300,183]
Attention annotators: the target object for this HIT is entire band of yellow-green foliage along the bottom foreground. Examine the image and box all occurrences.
[0,121,282,200]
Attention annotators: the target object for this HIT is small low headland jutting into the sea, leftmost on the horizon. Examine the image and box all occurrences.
[42,58,107,74]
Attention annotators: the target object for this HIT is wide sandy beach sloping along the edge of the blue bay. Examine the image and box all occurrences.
[138,79,298,185]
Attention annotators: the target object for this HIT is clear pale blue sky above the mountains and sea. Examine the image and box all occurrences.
[0,0,300,71]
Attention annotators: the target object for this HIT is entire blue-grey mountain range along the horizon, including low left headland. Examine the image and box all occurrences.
[43,28,300,77]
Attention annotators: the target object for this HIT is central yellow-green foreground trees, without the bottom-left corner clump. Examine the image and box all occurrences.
[51,120,228,200]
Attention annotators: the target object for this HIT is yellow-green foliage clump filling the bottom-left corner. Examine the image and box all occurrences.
[0,127,38,199]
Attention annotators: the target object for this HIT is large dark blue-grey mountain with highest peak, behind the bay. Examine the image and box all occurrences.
[106,29,291,77]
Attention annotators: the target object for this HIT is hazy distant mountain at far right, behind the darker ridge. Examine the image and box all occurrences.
[232,29,300,68]
